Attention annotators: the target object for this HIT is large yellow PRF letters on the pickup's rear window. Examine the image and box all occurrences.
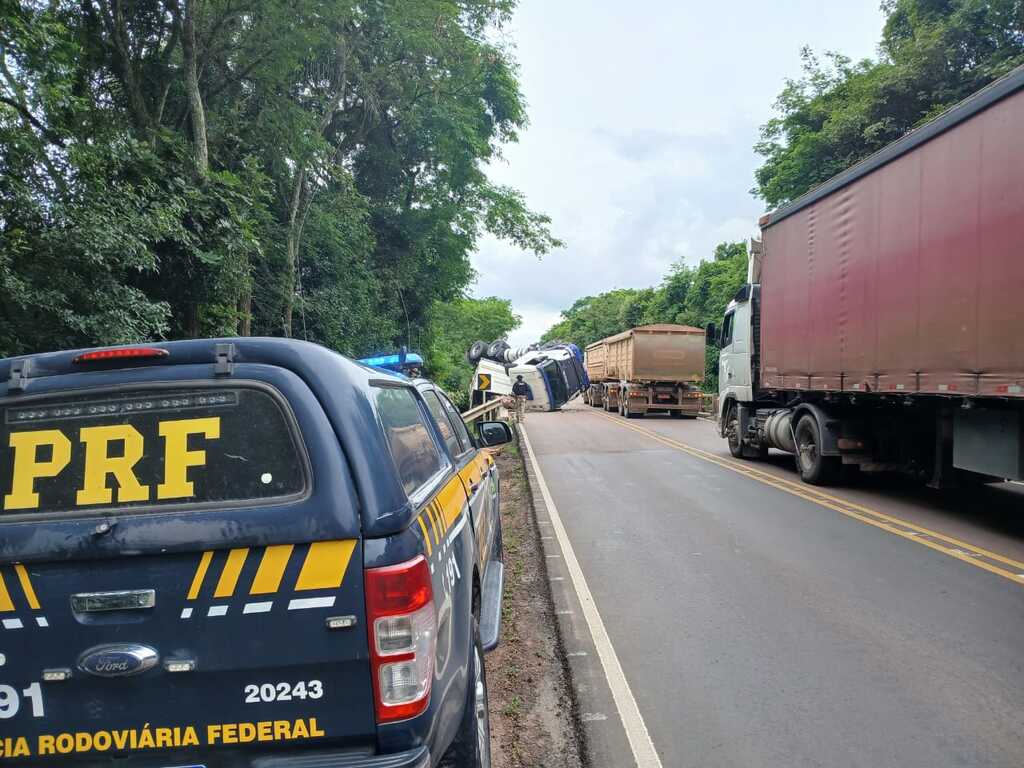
[3,416,220,512]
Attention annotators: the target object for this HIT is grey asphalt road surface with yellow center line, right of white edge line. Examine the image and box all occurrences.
[526,406,1024,768]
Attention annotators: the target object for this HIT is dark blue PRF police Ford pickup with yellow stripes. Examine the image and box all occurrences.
[0,339,511,768]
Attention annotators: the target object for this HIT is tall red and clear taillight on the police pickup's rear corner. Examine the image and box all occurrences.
[366,555,437,723]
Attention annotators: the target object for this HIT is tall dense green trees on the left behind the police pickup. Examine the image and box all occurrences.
[0,0,559,393]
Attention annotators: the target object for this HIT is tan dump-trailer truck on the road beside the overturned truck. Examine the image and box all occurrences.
[584,324,705,419]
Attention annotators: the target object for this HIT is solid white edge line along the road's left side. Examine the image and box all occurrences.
[519,424,662,768]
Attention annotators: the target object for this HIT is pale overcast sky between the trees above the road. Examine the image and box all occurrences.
[471,0,883,344]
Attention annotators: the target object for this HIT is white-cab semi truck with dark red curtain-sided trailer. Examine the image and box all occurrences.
[708,68,1024,487]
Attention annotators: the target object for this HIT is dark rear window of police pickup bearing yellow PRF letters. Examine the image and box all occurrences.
[0,386,307,517]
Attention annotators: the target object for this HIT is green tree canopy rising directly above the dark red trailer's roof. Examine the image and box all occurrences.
[754,0,1024,208]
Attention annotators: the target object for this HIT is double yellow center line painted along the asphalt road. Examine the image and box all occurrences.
[595,414,1024,585]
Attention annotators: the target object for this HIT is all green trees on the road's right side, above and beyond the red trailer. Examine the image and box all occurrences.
[544,0,1024,391]
